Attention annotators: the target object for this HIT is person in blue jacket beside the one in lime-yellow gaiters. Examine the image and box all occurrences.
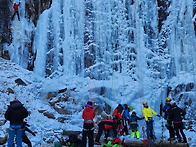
[122,104,131,135]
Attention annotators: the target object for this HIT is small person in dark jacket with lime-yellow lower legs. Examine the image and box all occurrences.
[129,110,144,139]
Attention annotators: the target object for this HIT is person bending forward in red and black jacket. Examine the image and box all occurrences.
[95,119,118,145]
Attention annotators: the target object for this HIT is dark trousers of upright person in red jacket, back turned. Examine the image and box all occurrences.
[81,123,94,147]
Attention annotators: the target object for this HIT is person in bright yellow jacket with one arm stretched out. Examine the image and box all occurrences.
[142,101,160,139]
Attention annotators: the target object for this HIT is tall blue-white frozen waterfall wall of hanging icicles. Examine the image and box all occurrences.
[4,0,196,84]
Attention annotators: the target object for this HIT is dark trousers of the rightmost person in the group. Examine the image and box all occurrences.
[174,122,187,142]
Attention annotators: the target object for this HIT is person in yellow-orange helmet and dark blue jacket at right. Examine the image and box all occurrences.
[162,97,174,141]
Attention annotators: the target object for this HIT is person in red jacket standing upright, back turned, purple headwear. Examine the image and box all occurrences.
[82,101,95,147]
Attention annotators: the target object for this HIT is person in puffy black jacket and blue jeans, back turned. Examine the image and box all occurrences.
[5,99,28,147]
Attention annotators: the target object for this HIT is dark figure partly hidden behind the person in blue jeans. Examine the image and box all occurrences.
[22,122,35,147]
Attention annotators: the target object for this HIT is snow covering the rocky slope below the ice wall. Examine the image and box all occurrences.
[0,58,196,147]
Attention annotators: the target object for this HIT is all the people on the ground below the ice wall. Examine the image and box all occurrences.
[5,98,187,147]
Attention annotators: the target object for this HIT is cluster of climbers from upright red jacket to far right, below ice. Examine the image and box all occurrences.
[82,98,187,147]
